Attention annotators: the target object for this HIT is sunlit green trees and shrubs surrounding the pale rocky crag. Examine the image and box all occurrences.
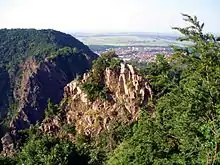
[0,15,220,165]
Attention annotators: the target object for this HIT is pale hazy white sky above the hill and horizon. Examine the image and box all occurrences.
[0,0,220,33]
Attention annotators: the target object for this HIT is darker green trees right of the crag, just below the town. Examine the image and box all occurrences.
[132,54,182,101]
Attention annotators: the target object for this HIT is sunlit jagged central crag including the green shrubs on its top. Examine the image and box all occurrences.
[41,52,152,139]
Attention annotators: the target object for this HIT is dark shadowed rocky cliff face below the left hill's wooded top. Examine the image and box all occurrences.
[1,53,96,153]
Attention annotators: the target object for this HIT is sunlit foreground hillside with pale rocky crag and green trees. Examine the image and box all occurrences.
[0,15,220,165]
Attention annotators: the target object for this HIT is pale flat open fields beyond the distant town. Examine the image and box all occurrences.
[74,34,189,47]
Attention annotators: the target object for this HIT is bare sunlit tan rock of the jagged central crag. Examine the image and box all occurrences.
[63,63,152,136]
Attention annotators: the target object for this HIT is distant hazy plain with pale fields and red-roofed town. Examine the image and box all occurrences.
[73,33,189,62]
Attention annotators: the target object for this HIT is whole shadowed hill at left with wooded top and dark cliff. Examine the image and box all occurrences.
[0,29,97,143]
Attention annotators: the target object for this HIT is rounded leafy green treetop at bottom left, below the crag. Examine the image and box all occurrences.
[18,136,86,165]
